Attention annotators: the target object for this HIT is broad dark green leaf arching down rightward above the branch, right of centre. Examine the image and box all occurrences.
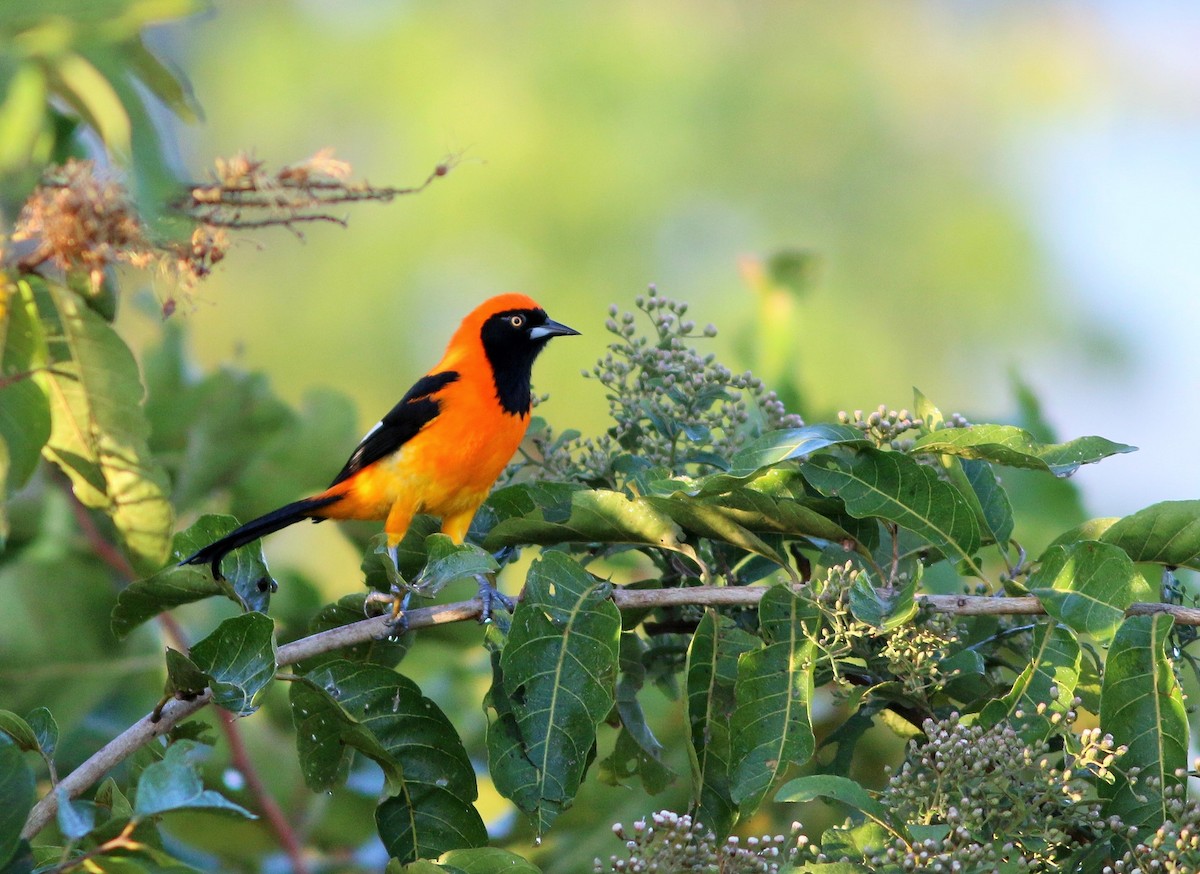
[800,449,980,567]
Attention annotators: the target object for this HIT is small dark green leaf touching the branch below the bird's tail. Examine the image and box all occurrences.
[191,612,275,717]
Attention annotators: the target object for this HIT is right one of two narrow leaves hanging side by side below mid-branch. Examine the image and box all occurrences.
[730,586,820,815]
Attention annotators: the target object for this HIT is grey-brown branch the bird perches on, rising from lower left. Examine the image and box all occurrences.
[22,586,1200,839]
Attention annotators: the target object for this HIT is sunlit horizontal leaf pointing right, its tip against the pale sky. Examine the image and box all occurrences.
[912,425,1138,477]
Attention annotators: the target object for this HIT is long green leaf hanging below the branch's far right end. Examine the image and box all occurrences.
[1100,613,1189,830]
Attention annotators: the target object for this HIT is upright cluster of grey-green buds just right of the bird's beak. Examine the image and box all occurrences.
[535,294,804,483]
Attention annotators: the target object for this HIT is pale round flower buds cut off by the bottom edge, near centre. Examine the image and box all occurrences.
[593,810,816,874]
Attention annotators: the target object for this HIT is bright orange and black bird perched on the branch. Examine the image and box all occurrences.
[181,294,578,615]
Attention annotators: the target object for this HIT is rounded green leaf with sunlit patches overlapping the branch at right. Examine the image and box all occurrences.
[1026,540,1150,643]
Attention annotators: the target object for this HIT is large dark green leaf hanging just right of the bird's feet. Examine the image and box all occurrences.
[487,552,620,834]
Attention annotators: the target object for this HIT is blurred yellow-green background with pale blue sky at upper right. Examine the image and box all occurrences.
[108,0,1200,552]
